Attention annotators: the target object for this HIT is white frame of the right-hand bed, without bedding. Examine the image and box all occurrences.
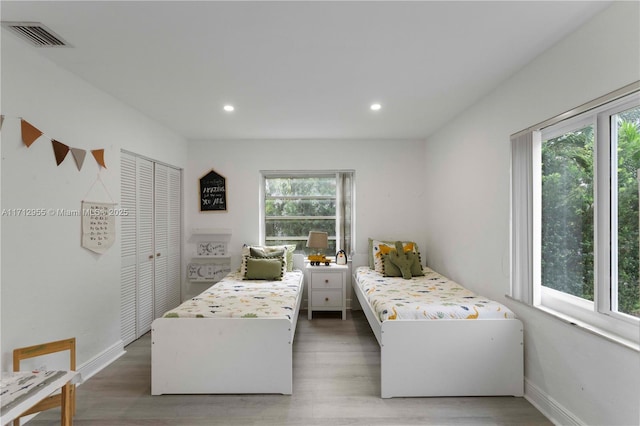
[352,265,524,398]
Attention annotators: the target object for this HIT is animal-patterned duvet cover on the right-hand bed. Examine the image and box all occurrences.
[356,266,516,321]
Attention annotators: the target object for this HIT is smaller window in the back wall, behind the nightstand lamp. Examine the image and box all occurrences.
[262,171,354,256]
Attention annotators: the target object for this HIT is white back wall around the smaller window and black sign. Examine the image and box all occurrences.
[184,140,425,300]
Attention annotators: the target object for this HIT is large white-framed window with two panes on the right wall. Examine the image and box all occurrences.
[512,88,640,345]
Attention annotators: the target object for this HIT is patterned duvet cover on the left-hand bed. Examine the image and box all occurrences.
[163,270,303,321]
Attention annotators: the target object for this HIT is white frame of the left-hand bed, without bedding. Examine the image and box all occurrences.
[151,255,304,395]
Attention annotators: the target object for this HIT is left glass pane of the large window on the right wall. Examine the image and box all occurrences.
[539,116,595,302]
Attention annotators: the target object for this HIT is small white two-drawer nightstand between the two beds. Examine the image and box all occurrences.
[306,263,349,320]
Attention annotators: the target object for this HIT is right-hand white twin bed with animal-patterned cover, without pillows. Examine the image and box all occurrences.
[352,266,524,398]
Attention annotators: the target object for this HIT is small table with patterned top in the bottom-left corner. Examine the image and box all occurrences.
[0,371,78,426]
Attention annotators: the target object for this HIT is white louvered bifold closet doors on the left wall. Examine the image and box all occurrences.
[120,151,182,345]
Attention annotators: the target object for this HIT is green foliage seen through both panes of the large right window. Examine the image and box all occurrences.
[541,108,640,317]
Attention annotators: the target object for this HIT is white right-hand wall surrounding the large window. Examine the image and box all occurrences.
[424,2,640,425]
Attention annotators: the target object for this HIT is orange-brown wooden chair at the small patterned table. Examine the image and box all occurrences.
[13,337,76,426]
